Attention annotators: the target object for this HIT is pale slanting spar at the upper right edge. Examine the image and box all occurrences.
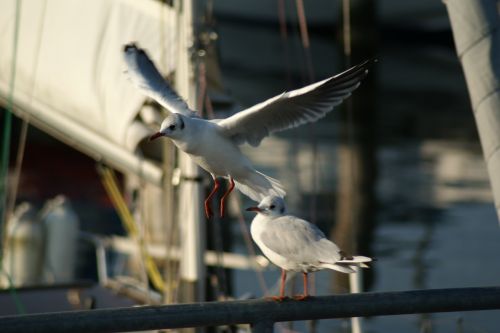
[444,0,500,222]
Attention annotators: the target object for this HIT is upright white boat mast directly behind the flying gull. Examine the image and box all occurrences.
[175,0,205,302]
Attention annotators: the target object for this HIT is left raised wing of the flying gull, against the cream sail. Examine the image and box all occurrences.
[123,43,194,116]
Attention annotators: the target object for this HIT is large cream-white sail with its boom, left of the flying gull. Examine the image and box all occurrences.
[0,0,177,184]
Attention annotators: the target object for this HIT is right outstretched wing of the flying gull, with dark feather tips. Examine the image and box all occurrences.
[219,60,373,146]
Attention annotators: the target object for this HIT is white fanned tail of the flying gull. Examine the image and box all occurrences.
[235,171,286,202]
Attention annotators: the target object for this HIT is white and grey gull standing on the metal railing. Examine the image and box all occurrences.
[247,196,372,301]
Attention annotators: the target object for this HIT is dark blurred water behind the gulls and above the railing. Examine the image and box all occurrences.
[216,1,500,332]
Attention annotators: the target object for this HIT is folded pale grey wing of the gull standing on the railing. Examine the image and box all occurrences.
[261,216,340,263]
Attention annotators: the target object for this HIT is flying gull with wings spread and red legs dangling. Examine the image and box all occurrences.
[124,43,372,217]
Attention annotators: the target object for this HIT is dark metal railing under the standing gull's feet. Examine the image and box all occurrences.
[0,287,500,333]
